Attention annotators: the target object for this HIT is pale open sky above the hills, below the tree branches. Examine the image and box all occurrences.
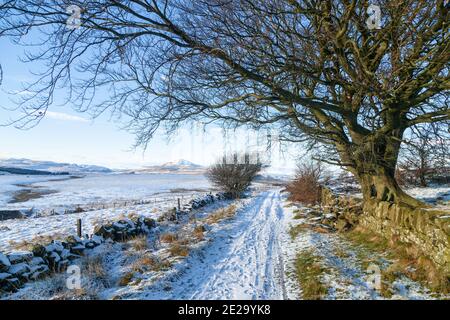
[0,39,297,168]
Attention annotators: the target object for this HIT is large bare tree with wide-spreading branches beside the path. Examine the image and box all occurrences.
[0,0,450,206]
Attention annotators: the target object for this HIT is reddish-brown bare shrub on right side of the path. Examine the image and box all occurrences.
[286,162,323,204]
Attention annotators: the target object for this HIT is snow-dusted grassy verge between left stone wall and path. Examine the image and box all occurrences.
[0,200,239,300]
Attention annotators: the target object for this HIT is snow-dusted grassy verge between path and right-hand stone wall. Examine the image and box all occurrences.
[281,202,442,300]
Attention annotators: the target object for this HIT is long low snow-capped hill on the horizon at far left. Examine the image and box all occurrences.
[0,159,112,174]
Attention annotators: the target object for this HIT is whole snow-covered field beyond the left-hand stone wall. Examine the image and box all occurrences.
[0,174,214,251]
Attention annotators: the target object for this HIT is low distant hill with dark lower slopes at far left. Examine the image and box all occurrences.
[0,159,112,175]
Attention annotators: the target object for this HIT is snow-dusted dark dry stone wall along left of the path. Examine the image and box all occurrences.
[0,193,229,293]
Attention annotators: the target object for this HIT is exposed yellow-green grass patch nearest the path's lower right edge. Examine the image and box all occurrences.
[295,250,328,300]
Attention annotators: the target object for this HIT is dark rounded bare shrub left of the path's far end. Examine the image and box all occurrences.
[206,154,262,198]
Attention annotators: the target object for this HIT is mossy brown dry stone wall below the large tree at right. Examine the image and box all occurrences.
[322,188,450,277]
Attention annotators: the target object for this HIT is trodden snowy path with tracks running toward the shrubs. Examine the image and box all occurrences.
[137,191,286,299]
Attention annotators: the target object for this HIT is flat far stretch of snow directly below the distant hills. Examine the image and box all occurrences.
[0,174,210,211]
